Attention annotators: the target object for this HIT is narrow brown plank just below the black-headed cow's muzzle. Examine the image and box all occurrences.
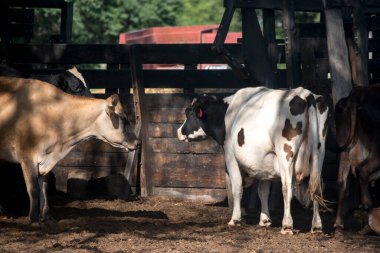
[150,138,223,154]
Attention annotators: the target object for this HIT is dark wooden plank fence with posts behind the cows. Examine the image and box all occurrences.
[2,0,380,204]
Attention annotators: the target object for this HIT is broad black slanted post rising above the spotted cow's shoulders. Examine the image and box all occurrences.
[241,8,275,88]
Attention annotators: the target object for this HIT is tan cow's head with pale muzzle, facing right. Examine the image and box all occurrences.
[97,94,140,151]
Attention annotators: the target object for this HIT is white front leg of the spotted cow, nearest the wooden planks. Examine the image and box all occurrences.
[226,155,243,226]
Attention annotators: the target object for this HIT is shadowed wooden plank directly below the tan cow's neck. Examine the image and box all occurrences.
[57,151,127,167]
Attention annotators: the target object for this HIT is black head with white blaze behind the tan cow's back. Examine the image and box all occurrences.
[58,66,93,97]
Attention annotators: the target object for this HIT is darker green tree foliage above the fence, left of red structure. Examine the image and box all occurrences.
[35,0,182,43]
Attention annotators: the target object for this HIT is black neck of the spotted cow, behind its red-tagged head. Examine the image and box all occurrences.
[202,100,228,146]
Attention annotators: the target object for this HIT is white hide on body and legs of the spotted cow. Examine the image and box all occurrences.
[224,87,328,233]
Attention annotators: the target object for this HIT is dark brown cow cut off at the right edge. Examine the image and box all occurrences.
[334,84,380,228]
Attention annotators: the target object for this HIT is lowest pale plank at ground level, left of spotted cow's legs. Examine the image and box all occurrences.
[152,187,226,202]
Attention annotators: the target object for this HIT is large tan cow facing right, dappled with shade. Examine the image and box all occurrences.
[0,77,139,222]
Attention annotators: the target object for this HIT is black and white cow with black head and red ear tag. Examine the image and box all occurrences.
[177,87,328,234]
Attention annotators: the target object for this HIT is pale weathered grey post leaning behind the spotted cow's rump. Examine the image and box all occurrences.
[323,0,352,106]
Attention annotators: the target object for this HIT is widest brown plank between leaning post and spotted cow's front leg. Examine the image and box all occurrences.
[152,153,225,188]
